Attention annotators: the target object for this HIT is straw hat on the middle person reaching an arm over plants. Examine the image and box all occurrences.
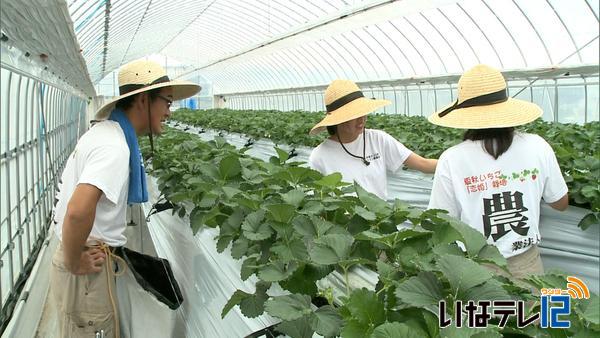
[309,80,391,135]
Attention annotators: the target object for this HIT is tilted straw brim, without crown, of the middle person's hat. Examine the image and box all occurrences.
[309,97,392,135]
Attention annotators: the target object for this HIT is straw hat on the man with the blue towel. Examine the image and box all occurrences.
[95,60,201,120]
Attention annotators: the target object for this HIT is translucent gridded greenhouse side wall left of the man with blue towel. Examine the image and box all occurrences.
[0,64,87,322]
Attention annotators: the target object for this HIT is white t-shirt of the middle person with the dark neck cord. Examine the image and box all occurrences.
[308,129,412,199]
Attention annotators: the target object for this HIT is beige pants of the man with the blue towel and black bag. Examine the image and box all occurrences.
[50,243,116,338]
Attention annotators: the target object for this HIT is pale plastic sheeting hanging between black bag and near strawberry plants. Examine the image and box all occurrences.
[144,177,283,337]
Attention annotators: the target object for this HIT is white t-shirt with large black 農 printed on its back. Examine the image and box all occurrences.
[429,133,567,258]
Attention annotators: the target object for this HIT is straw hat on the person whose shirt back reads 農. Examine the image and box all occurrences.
[429,65,542,129]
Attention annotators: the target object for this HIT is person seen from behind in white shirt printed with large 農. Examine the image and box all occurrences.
[429,65,568,278]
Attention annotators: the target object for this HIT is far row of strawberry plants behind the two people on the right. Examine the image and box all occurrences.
[173,109,600,230]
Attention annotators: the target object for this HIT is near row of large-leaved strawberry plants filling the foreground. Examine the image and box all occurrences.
[142,130,599,337]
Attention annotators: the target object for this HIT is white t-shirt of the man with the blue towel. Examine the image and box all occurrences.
[54,120,129,246]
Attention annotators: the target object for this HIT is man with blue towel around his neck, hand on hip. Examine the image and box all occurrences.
[50,60,200,337]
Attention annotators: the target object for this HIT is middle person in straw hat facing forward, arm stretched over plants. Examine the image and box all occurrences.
[309,80,437,199]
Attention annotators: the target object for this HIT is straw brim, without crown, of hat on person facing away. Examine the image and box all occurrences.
[428,98,542,129]
